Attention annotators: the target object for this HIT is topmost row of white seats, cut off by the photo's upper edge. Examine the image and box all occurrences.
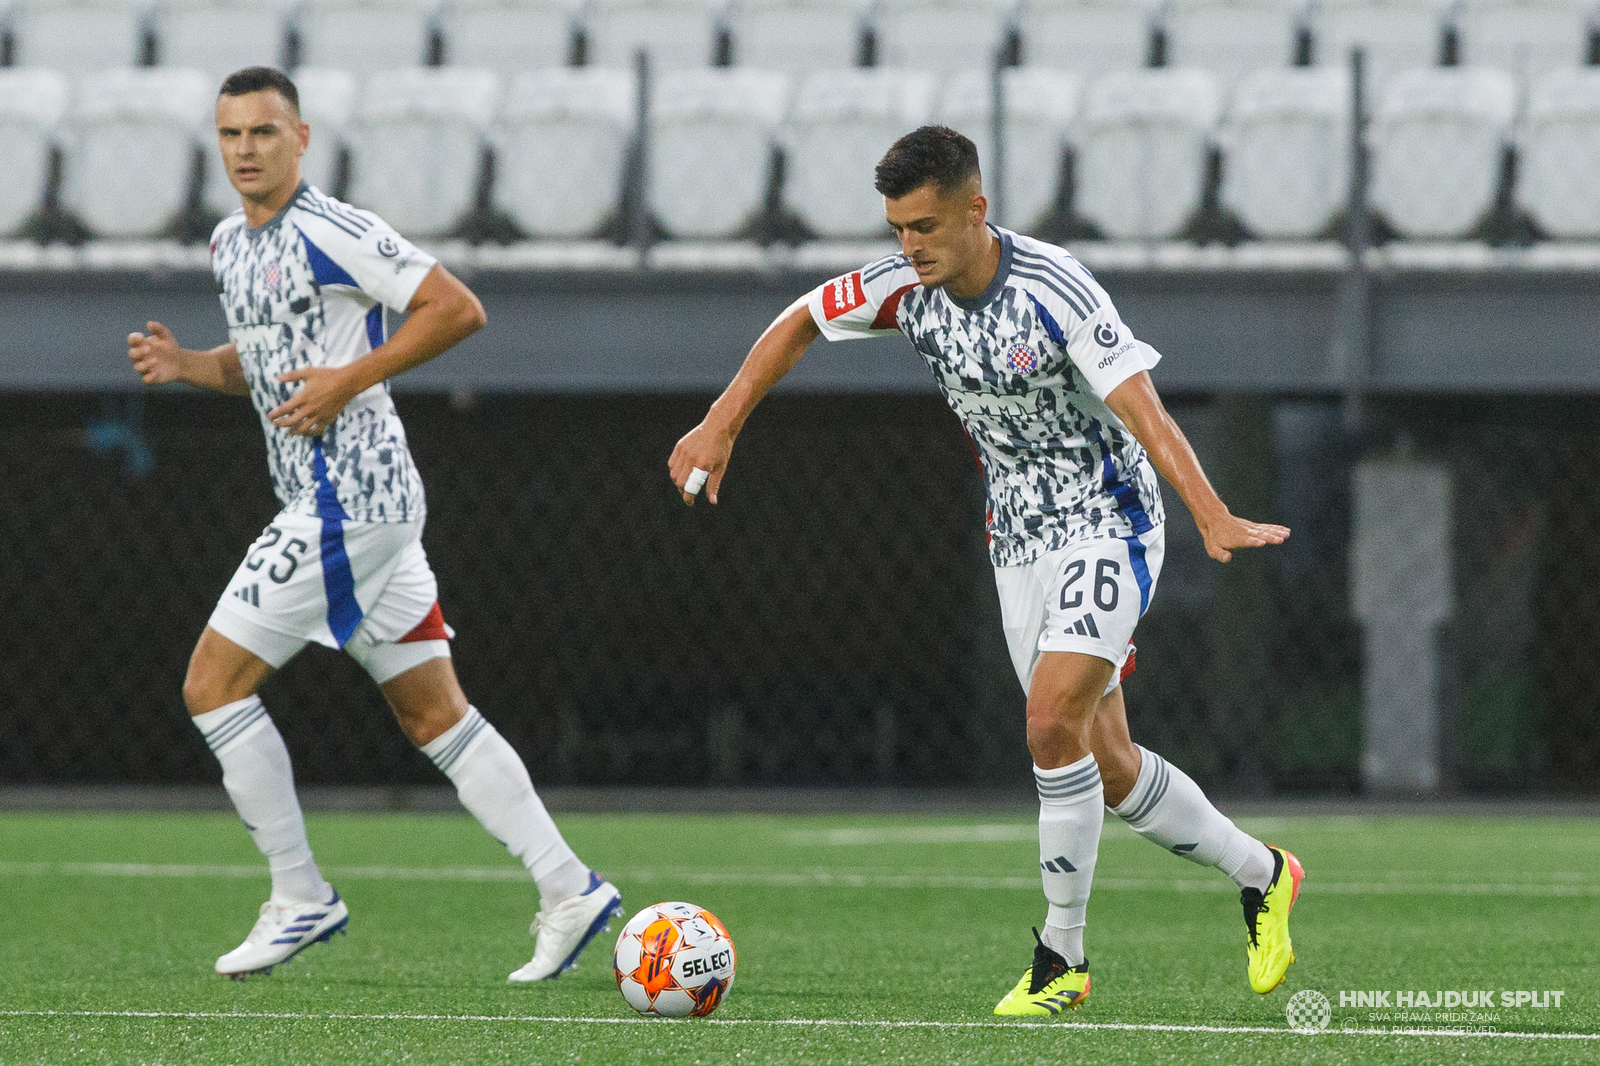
[0,0,1594,77]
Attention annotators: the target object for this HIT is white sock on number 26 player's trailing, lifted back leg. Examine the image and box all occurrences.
[1110,747,1272,892]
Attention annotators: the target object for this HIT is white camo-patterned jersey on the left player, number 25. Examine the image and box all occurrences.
[211,184,435,522]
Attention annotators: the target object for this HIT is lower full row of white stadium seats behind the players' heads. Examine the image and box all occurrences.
[0,67,1600,240]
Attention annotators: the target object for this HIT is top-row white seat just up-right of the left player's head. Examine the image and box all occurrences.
[296,0,429,74]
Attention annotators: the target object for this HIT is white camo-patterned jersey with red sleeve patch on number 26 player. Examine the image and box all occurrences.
[810,227,1163,567]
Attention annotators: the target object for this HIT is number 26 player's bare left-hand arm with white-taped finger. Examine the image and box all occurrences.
[667,295,822,507]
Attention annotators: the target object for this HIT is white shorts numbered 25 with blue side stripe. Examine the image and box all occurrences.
[208,514,454,685]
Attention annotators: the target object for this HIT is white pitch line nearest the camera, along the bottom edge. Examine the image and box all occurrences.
[0,1010,1600,1040]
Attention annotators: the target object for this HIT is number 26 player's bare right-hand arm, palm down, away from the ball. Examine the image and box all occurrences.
[1106,370,1290,562]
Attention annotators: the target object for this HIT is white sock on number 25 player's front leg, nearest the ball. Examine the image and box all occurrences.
[422,707,589,909]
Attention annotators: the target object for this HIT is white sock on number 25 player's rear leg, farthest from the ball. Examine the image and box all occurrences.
[194,696,333,903]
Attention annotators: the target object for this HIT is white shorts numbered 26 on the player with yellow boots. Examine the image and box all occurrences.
[995,525,1166,693]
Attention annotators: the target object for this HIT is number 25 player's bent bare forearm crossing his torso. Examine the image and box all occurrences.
[267,264,488,437]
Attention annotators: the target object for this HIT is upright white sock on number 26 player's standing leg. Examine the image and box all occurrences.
[1034,755,1106,967]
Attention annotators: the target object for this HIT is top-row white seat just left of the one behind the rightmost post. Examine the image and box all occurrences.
[1165,0,1304,80]
